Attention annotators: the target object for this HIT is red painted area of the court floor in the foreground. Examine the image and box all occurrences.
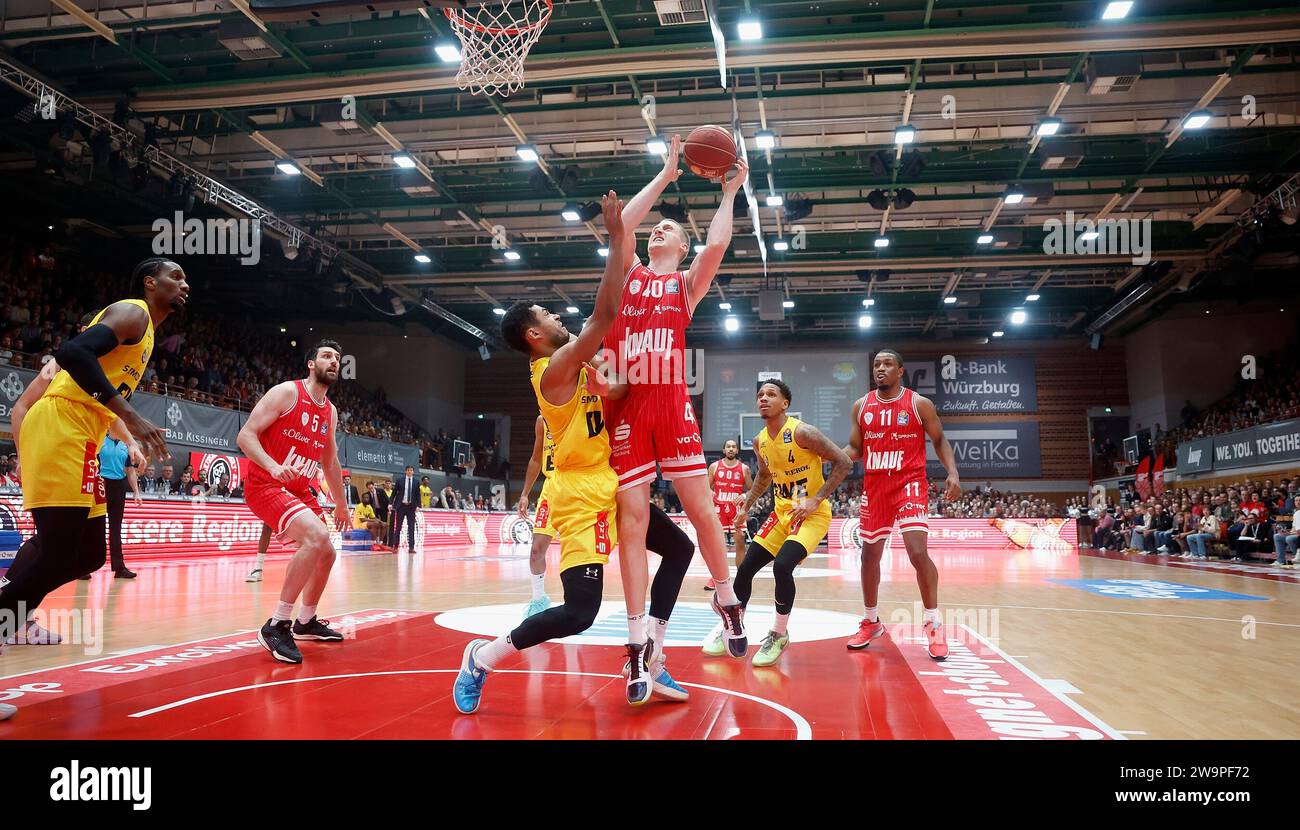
[0,609,1117,740]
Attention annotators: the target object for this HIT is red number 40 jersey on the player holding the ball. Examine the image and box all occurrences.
[605,263,690,403]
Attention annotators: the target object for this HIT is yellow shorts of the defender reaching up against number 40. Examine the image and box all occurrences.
[546,467,619,572]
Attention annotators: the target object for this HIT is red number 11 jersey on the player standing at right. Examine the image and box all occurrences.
[858,389,926,492]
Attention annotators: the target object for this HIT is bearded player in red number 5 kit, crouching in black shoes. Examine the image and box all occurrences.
[237,340,351,663]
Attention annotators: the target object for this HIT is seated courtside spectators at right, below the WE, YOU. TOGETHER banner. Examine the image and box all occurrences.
[1076,479,1300,567]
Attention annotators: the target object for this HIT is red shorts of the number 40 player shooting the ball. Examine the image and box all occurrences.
[606,385,709,490]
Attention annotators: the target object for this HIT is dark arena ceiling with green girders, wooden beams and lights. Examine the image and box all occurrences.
[0,0,1300,343]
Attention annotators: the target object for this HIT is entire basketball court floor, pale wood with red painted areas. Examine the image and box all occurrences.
[0,537,1300,739]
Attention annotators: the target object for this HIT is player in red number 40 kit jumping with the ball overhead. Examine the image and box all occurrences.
[605,135,749,658]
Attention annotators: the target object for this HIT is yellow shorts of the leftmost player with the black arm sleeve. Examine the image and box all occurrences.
[18,395,109,519]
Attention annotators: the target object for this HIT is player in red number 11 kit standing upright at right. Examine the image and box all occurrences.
[844,349,962,660]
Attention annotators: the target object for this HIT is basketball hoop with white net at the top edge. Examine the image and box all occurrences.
[443,0,554,95]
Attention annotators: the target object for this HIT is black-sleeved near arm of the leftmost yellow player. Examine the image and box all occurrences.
[55,302,166,458]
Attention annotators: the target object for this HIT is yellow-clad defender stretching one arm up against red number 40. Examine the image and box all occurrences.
[452,191,651,714]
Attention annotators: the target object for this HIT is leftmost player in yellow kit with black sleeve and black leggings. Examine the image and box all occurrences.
[0,259,190,697]
